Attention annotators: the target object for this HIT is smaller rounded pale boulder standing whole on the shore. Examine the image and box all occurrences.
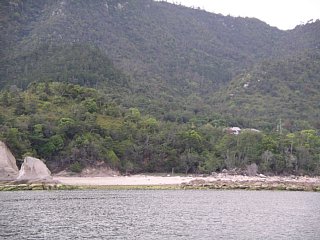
[17,157,52,181]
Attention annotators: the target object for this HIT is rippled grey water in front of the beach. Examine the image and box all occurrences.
[0,190,320,240]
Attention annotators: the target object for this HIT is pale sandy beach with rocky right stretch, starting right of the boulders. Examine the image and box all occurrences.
[53,174,320,191]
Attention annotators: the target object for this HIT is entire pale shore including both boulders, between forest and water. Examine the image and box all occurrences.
[0,138,320,192]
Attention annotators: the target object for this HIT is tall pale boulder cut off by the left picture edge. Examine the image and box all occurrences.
[0,141,19,181]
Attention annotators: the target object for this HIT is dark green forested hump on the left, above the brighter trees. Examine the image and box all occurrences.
[0,44,129,91]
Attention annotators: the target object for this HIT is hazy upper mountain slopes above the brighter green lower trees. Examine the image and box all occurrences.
[0,0,320,128]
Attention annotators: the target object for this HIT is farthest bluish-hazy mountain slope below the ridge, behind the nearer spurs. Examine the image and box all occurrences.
[2,0,282,94]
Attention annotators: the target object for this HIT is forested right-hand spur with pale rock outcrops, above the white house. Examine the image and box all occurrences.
[214,50,320,131]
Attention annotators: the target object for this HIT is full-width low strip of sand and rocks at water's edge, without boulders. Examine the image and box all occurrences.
[0,174,320,192]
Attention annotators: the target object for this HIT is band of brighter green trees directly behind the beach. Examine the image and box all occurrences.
[0,82,320,174]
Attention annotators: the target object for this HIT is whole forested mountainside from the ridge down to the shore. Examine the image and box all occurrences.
[0,0,320,174]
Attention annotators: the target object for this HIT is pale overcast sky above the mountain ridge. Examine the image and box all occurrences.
[159,0,320,30]
